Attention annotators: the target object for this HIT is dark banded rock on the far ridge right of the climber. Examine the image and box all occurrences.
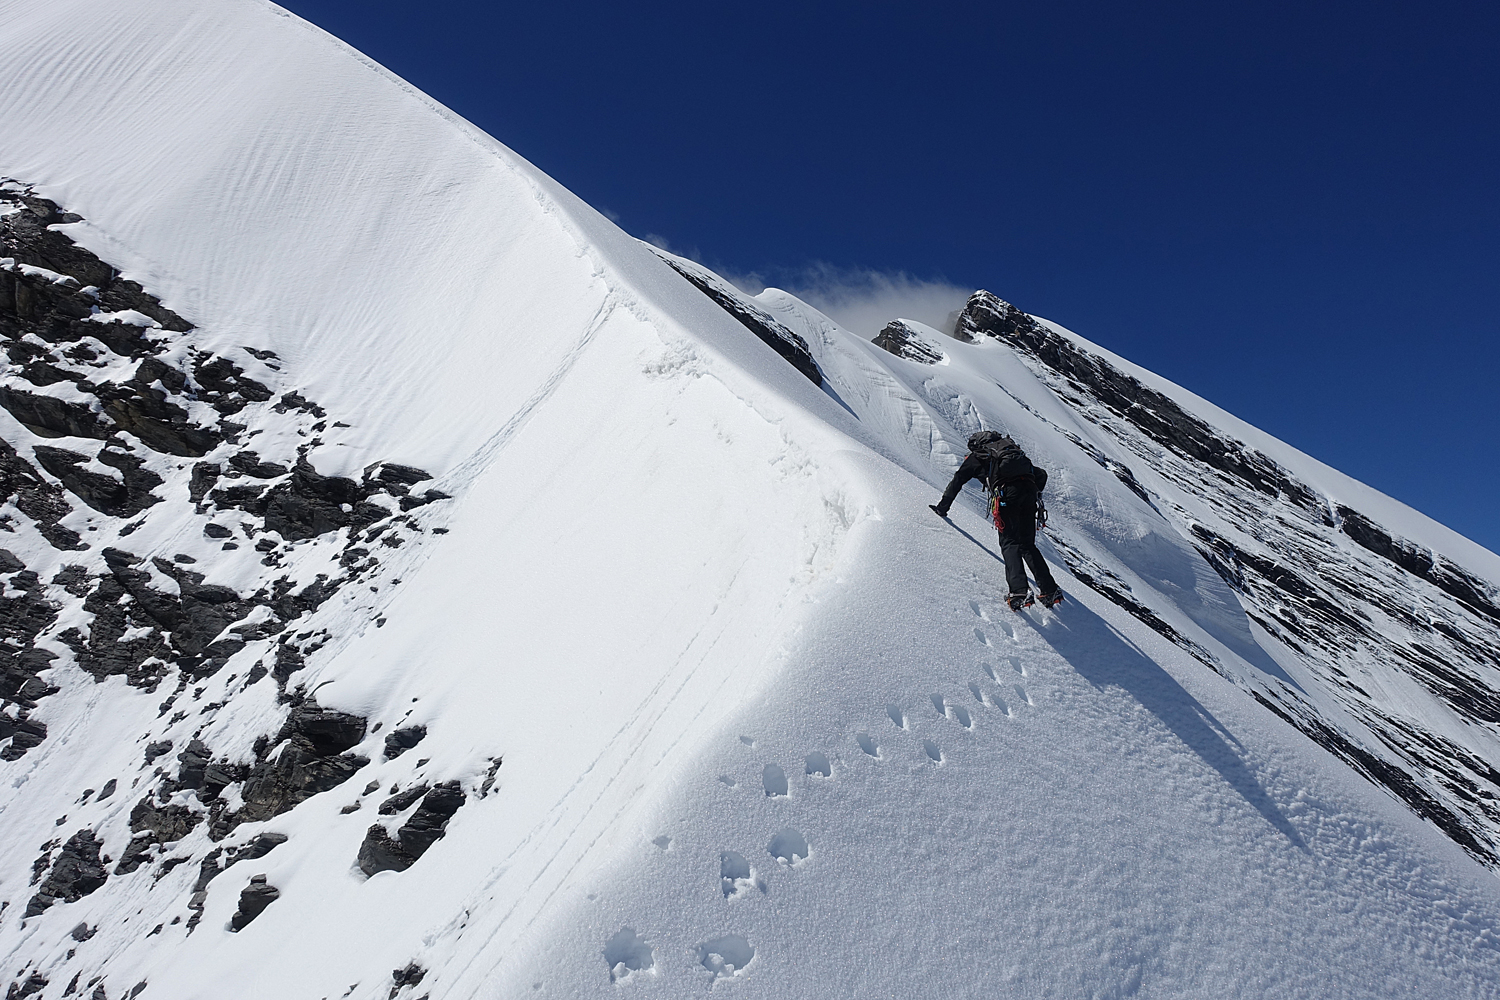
[954,284,1500,867]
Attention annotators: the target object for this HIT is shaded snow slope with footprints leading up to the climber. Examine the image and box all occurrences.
[489,479,1497,997]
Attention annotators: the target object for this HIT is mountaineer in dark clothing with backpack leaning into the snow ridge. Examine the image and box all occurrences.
[932,430,1062,612]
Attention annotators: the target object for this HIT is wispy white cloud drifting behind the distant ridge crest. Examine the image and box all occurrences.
[726,264,974,337]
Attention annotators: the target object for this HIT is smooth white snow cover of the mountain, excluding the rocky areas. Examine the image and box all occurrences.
[0,1,1500,1000]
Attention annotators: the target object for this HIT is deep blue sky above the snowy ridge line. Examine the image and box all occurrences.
[287,0,1500,550]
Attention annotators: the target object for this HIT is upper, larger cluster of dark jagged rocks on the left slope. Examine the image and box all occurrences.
[0,184,447,749]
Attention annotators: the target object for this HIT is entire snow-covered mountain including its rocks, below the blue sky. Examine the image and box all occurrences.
[0,0,1500,1000]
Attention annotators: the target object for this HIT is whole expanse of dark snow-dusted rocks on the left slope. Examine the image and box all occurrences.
[0,181,464,996]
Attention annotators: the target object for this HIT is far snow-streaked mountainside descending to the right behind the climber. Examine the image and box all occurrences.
[956,294,1500,867]
